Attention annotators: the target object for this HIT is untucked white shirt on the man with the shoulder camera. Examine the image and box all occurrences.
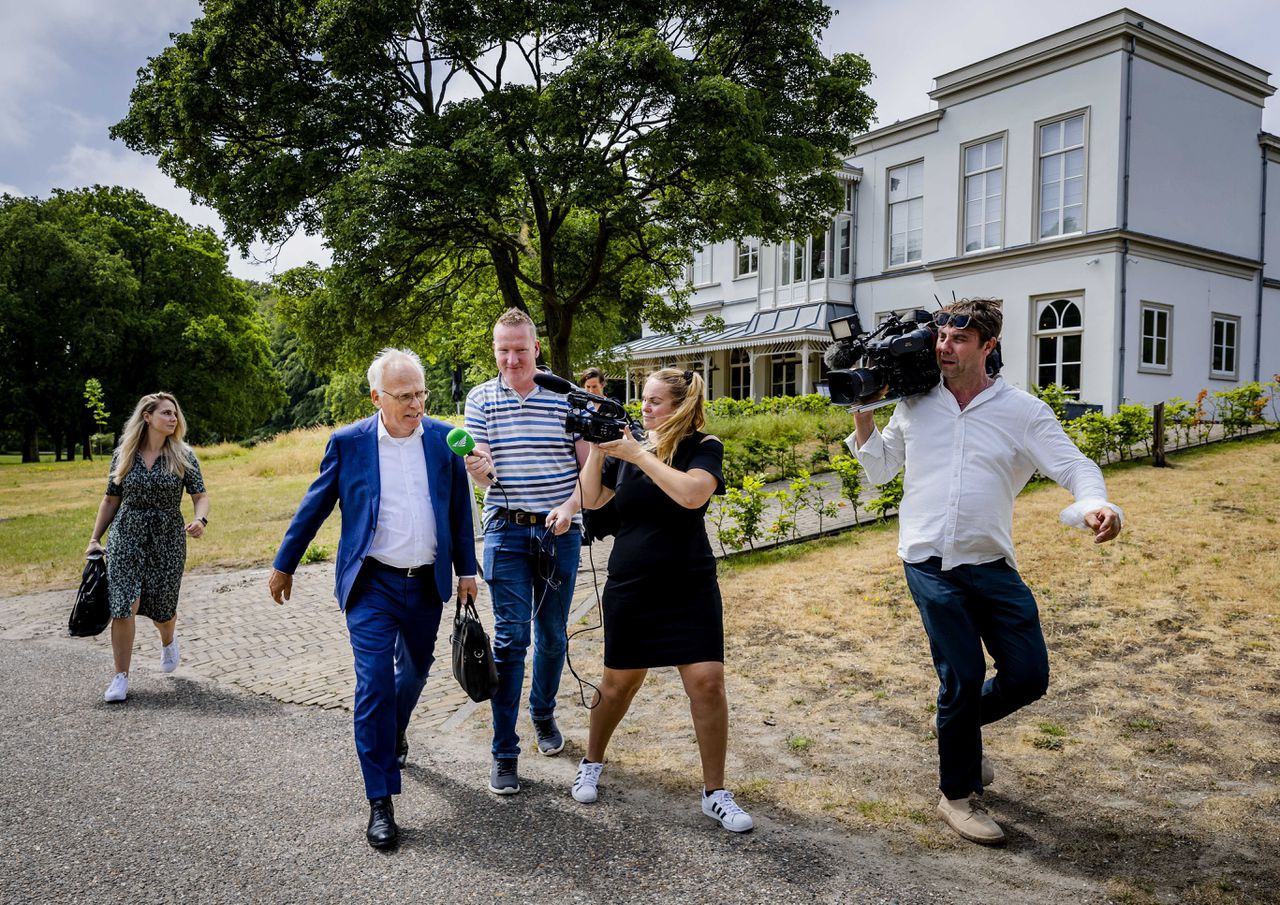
[845,378,1124,570]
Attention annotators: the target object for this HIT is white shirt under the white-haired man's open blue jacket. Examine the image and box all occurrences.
[366,415,435,568]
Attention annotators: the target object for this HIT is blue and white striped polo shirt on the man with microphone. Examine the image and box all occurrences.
[466,374,582,525]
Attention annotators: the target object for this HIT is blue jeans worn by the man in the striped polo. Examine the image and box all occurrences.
[484,521,582,758]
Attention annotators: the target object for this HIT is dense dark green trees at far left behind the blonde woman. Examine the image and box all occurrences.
[0,187,285,461]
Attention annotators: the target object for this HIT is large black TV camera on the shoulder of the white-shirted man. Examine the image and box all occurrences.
[823,308,940,410]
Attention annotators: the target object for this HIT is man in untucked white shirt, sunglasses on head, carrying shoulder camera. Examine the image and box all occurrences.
[846,298,1123,845]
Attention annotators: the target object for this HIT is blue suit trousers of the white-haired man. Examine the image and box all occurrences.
[347,567,443,799]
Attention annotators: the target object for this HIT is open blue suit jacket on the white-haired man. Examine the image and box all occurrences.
[273,413,476,609]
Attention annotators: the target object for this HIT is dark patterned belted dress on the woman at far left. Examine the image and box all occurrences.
[106,452,205,622]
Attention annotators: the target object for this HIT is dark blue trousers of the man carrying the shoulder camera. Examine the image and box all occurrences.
[902,557,1048,799]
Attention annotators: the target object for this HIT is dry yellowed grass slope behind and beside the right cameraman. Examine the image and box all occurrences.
[555,434,1280,902]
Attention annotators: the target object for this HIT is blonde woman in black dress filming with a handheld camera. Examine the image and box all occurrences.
[573,367,753,832]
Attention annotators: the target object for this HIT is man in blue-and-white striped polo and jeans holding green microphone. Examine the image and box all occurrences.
[466,308,582,795]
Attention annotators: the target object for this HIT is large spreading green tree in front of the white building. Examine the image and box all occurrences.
[111,0,873,372]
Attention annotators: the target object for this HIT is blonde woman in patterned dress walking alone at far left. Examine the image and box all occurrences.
[84,393,209,703]
